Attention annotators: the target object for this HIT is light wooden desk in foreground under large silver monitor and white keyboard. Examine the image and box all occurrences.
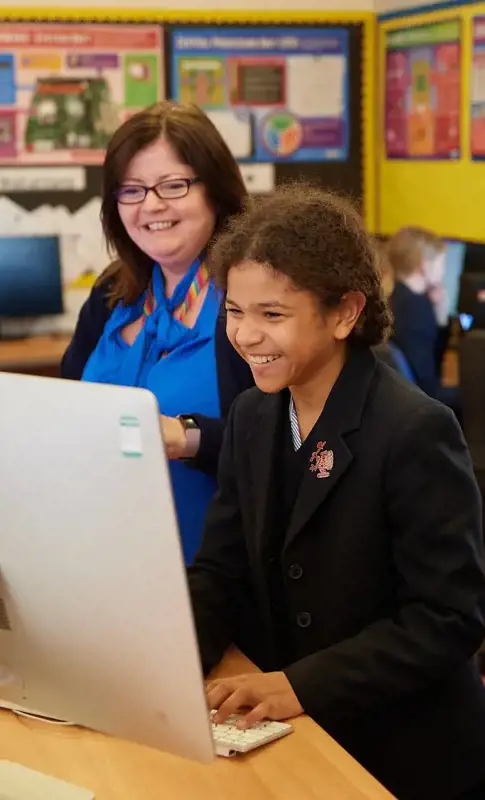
[0,652,392,800]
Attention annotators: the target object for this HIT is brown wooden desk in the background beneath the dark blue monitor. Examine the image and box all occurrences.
[0,336,71,376]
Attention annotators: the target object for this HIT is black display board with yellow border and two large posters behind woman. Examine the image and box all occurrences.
[0,7,376,331]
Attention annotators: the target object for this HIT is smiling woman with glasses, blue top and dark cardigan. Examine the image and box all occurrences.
[62,102,253,563]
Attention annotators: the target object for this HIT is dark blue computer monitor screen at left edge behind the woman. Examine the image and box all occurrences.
[0,236,64,317]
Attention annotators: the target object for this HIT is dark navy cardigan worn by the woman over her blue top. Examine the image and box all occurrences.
[61,285,254,474]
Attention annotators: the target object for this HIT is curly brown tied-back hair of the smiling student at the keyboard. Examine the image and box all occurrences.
[209,183,392,347]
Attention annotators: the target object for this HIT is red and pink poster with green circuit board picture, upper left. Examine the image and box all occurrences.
[0,23,164,165]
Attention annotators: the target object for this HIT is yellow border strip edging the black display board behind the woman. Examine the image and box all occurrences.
[0,6,377,232]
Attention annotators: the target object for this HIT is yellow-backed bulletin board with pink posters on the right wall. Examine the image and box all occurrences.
[376,3,485,242]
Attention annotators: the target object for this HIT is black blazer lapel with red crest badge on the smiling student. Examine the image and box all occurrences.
[285,348,376,547]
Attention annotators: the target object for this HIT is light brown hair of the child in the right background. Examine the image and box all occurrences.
[385,227,445,280]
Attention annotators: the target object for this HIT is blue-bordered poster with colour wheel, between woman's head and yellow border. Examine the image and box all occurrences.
[172,27,349,161]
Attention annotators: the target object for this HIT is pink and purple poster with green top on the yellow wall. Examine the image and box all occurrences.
[385,20,461,159]
